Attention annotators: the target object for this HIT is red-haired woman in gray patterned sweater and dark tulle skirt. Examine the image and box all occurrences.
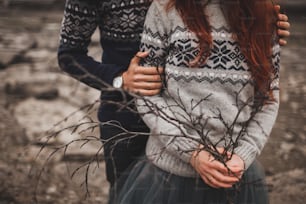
[110,0,279,204]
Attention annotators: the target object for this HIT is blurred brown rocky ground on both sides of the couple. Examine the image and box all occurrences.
[0,0,306,204]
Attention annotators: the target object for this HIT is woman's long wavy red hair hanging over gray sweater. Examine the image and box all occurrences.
[167,0,276,99]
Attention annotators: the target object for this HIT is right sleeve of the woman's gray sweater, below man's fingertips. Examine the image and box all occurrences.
[235,44,280,169]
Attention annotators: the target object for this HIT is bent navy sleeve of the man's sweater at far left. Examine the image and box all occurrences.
[58,0,124,89]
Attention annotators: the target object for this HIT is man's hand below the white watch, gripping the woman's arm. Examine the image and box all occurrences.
[122,52,164,96]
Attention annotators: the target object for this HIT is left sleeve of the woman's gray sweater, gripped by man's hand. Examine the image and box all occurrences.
[136,1,198,163]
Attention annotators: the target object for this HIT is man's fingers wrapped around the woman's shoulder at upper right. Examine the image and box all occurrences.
[275,5,290,45]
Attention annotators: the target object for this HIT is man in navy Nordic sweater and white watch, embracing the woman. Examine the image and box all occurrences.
[58,0,290,185]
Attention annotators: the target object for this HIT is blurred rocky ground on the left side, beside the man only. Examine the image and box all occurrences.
[0,0,108,204]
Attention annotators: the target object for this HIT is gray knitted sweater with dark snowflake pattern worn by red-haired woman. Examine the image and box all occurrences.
[137,0,280,177]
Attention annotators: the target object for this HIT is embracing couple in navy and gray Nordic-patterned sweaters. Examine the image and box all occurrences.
[59,0,290,203]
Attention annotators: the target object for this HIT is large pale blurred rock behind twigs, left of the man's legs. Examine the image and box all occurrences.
[14,98,102,161]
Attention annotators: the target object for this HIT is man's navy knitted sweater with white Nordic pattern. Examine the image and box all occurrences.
[58,0,151,88]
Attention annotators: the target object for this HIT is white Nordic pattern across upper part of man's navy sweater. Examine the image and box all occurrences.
[61,0,151,49]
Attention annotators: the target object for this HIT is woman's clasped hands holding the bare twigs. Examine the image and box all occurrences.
[190,150,241,188]
